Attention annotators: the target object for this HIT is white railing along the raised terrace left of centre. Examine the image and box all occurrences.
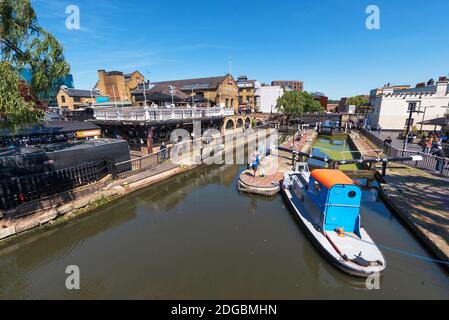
[94,107,234,121]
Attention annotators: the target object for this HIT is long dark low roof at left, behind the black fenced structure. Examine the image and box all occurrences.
[0,120,100,136]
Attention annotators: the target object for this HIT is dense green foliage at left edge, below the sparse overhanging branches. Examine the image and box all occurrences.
[0,61,43,130]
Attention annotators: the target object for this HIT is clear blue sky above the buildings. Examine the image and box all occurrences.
[32,0,449,99]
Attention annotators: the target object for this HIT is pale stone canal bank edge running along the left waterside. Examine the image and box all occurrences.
[0,127,272,245]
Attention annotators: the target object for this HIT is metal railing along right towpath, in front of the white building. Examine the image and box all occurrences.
[360,128,449,177]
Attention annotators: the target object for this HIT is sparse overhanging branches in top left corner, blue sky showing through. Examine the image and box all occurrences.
[0,0,70,102]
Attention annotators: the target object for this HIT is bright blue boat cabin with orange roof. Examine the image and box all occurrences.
[307,169,362,236]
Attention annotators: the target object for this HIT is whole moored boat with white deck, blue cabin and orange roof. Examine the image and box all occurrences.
[281,163,386,278]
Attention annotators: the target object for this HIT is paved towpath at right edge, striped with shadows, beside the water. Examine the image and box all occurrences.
[381,165,449,270]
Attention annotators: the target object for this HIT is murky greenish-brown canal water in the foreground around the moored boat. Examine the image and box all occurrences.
[0,166,449,299]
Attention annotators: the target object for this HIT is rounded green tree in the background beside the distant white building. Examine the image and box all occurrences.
[277,91,324,122]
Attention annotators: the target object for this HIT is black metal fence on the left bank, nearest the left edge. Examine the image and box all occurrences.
[0,161,110,210]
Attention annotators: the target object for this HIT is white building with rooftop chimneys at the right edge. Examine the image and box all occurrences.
[367,78,449,130]
